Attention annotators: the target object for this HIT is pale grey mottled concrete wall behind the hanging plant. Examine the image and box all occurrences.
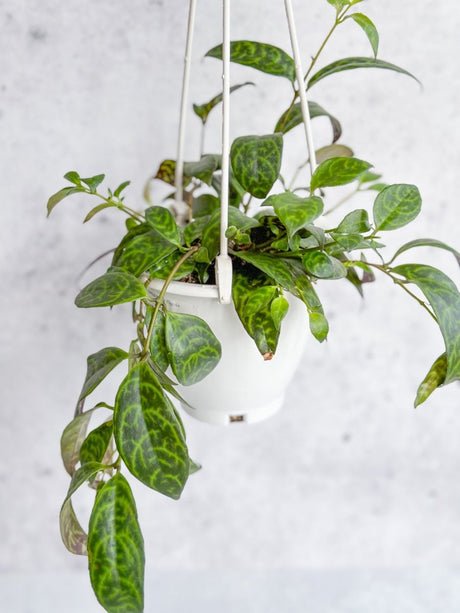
[0,0,460,610]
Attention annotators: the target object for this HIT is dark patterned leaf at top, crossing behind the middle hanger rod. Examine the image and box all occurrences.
[205,40,295,83]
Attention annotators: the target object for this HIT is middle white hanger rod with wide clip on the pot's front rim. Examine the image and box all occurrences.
[216,0,232,304]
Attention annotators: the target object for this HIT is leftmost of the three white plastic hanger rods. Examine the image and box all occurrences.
[174,0,196,211]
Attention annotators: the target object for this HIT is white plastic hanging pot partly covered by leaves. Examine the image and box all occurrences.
[148,279,308,425]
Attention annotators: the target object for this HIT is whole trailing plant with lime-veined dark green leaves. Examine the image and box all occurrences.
[48,0,460,613]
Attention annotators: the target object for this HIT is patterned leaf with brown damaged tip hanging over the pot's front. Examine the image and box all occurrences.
[232,270,280,360]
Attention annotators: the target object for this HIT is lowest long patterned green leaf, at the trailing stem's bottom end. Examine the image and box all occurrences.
[88,473,145,613]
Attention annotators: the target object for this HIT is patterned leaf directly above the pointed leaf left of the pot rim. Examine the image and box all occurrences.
[112,230,176,277]
